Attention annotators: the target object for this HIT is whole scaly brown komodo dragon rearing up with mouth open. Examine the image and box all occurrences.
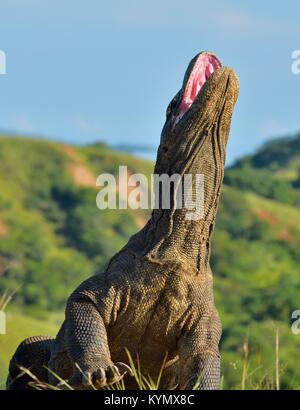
[7,52,239,389]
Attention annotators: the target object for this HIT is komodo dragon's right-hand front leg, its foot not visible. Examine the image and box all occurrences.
[179,308,221,390]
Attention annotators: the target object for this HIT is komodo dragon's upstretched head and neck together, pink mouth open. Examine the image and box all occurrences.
[145,52,239,266]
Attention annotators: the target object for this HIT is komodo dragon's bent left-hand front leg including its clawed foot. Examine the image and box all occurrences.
[64,277,130,387]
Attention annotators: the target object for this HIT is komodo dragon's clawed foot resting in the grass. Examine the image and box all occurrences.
[64,362,133,388]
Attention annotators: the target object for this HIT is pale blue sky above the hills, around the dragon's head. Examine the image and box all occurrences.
[0,0,300,161]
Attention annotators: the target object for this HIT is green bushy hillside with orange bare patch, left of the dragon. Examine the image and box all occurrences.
[0,137,153,311]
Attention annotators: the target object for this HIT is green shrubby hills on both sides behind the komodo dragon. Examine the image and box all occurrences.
[0,136,300,388]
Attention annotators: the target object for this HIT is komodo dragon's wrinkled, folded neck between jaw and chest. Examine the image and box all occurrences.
[144,133,225,272]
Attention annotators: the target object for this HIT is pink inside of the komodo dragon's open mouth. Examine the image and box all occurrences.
[178,54,221,117]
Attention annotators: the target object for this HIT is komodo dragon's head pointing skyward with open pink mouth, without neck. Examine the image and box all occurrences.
[155,52,239,177]
